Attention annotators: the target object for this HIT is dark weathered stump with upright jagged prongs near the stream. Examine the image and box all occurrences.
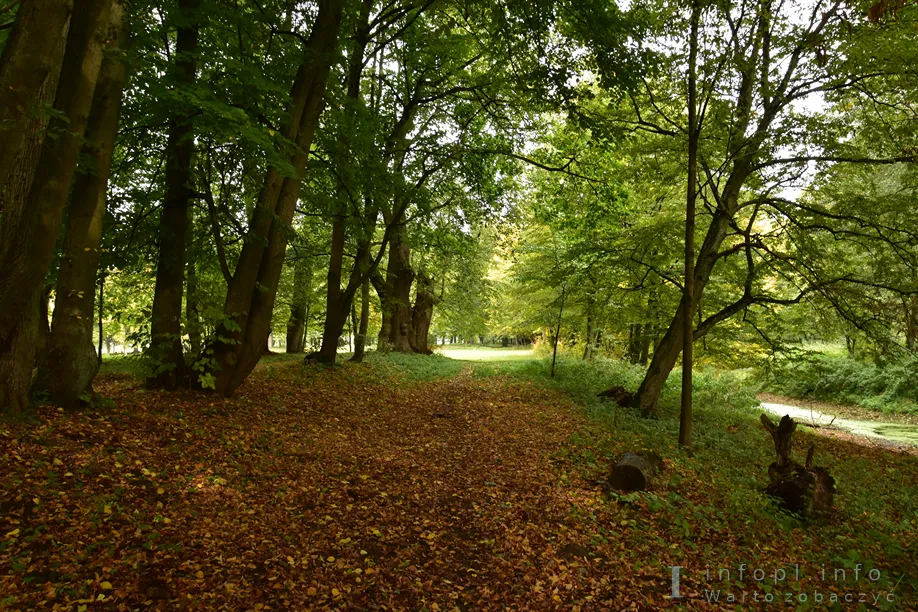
[761,414,835,516]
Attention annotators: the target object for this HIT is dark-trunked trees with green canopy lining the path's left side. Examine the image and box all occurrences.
[0,0,640,411]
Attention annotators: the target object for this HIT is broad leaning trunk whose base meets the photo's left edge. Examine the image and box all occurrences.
[0,0,111,411]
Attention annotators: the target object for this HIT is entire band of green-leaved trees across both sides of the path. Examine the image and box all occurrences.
[0,0,918,454]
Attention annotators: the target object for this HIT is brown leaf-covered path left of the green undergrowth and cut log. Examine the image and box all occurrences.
[0,362,644,610]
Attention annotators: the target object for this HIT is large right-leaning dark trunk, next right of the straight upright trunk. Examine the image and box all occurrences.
[214,0,344,396]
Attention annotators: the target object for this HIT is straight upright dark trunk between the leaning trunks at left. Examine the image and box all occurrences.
[147,0,200,389]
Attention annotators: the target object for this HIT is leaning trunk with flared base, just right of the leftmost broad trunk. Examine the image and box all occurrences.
[35,2,127,409]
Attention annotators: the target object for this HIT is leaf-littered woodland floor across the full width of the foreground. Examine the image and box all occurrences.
[0,358,918,610]
